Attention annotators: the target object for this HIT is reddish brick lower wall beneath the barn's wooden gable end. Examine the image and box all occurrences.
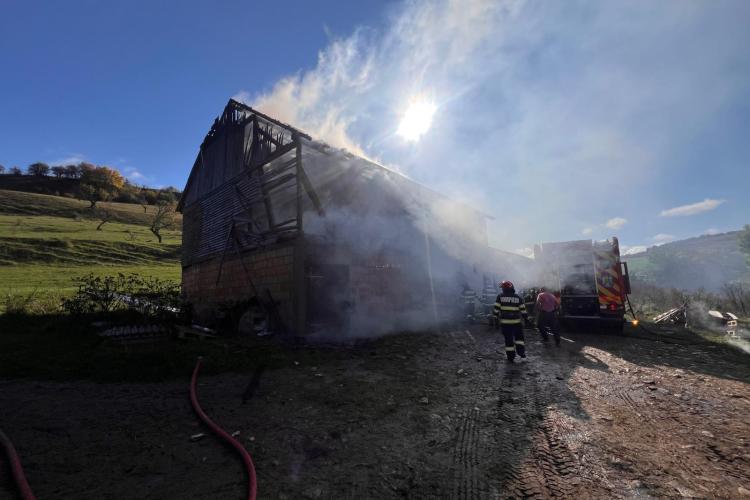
[182,243,296,328]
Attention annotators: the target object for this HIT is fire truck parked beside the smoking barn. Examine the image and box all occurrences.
[534,237,630,330]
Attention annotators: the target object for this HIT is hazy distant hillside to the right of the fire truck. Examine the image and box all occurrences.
[625,231,750,291]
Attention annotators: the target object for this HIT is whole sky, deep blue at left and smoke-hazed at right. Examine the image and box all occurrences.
[0,0,750,250]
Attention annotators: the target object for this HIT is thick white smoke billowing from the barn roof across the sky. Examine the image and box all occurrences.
[238,0,750,250]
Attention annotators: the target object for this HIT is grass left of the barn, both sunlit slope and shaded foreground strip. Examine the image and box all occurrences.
[0,190,272,381]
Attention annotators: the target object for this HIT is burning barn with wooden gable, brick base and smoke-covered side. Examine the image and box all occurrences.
[178,100,524,335]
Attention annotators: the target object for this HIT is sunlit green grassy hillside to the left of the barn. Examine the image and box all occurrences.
[0,190,181,297]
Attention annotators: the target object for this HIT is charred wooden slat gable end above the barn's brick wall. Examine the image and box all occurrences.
[182,101,314,266]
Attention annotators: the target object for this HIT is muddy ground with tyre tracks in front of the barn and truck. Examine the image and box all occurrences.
[0,327,750,499]
